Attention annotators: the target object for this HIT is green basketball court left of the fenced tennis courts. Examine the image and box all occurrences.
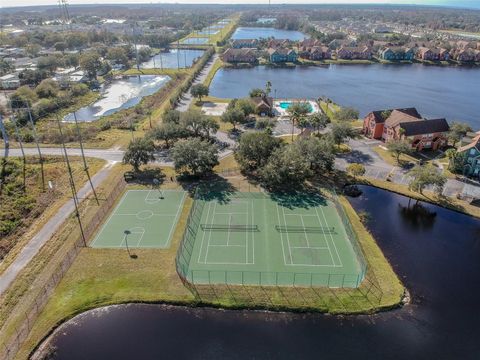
[90,189,186,248]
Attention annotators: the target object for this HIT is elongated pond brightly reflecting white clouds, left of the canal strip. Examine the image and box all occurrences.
[64,75,170,121]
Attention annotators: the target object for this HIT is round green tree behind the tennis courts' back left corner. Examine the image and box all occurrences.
[172,138,218,177]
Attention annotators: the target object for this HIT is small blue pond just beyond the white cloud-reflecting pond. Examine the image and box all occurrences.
[140,49,204,69]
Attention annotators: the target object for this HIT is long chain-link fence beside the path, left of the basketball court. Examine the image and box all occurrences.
[0,178,126,360]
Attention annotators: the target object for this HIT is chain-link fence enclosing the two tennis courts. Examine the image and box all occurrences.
[176,189,382,296]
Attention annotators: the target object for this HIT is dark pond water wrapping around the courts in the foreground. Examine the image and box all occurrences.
[36,187,480,360]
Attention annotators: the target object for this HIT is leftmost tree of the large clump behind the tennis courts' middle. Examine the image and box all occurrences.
[235,132,282,171]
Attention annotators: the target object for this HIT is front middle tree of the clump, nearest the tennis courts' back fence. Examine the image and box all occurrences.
[260,146,312,190]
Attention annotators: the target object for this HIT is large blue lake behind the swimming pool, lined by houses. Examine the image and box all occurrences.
[210,64,480,128]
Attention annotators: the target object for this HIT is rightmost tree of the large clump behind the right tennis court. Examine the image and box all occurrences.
[289,137,335,174]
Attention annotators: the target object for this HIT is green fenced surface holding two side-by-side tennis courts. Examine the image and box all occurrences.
[177,193,365,287]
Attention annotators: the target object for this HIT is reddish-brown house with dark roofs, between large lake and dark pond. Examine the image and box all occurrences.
[363,108,450,150]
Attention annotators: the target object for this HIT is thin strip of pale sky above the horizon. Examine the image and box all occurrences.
[0,0,480,9]
